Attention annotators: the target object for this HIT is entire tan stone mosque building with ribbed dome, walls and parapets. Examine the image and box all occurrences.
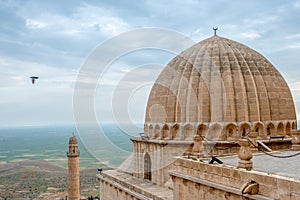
[97,34,300,200]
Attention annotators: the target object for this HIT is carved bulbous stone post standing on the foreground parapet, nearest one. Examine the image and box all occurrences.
[238,139,253,169]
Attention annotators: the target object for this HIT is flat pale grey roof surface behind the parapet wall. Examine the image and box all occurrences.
[218,150,300,180]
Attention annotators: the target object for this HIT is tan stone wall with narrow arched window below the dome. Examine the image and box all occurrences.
[131,138,193,186]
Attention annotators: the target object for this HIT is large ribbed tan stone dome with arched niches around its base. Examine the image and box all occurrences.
[144,35,296,140]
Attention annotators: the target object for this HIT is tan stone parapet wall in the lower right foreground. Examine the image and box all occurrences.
[170,158,300,200]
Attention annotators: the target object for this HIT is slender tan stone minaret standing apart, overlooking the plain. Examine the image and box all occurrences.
[67,134,80,200]
